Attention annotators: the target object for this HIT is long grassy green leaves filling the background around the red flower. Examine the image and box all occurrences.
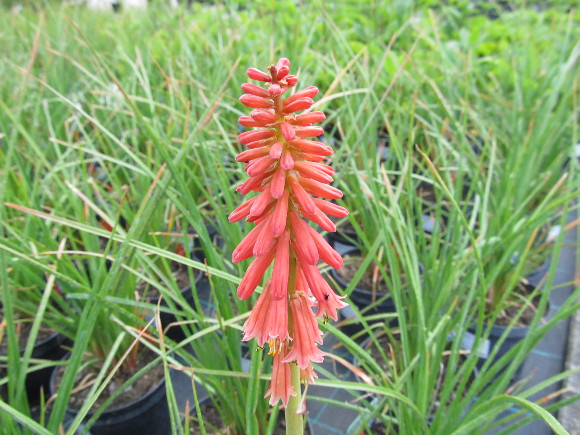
[0,0,580,434]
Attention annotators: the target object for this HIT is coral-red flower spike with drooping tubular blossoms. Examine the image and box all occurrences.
[229,58,348,406]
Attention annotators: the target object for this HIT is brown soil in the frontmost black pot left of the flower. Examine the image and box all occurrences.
[51,349,163,412]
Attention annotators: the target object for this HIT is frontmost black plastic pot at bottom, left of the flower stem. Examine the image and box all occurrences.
[50,355,171,435]
